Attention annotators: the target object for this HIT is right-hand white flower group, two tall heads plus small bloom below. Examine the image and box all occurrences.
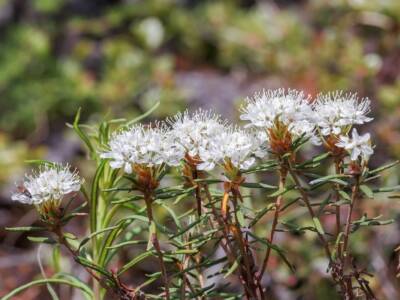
[241,89,373,160]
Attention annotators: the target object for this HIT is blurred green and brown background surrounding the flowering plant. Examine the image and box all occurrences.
[0,0,400,300]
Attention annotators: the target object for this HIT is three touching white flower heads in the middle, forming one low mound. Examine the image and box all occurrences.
[100,109,266,173]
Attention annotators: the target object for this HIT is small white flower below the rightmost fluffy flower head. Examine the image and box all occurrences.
[336,128,374,161]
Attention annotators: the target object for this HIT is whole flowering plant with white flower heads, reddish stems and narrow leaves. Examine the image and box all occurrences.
[3,89,394,300]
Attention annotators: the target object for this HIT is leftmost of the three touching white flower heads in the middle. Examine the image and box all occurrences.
[100,124,183,174]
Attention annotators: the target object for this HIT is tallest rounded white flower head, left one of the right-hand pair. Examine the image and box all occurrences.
[240,89,314,136]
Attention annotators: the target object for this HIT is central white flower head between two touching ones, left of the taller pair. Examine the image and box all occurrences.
[168,109,226,171]
